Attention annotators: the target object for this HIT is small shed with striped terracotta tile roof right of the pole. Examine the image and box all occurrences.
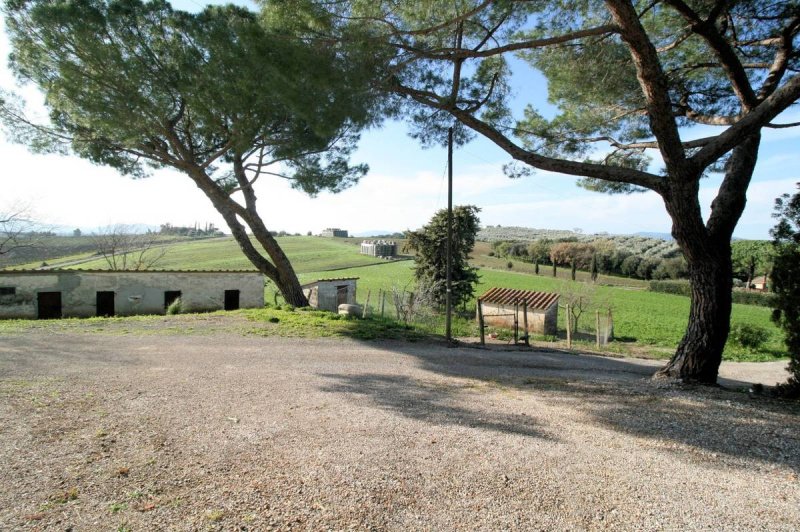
[478,287,559,335]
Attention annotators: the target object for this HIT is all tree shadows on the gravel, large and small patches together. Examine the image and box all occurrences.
[326,342,800,471]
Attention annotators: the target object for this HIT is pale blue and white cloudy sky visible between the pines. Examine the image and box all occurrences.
[0,0,800,239]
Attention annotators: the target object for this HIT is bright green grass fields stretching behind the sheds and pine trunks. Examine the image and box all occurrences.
[3,237,785,360]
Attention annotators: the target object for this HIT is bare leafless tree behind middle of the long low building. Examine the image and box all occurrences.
[92,224,167,271]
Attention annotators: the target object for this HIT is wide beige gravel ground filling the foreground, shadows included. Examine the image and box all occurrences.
[0,332,800,531]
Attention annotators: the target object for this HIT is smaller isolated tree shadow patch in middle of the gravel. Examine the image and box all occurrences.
[320,373,551,439]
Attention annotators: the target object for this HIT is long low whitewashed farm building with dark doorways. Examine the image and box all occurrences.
[0,270,264,319]
